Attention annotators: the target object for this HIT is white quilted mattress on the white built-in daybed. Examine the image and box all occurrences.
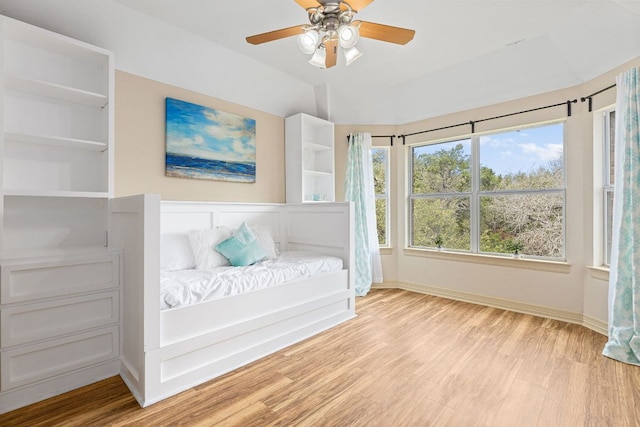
[160,251,342,310]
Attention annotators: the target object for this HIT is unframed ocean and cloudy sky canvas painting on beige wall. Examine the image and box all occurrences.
[165,98,256,182]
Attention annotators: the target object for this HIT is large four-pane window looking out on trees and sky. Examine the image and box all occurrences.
[409,123,565,258]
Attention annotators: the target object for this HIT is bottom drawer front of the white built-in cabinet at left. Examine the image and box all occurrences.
[0,326,119,391]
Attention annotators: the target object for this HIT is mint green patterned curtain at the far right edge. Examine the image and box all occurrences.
[603,68,640,365]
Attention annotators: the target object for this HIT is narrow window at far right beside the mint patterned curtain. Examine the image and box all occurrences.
[602,110,616,265]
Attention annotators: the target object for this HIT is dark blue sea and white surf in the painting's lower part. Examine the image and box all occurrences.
[165,153,256,182]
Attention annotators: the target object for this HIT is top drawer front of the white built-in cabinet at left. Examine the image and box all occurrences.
[1,255,119,304]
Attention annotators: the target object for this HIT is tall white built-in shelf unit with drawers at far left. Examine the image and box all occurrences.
[0,16,121,413]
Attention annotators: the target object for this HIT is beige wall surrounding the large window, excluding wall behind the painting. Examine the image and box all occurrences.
[336,54,640,330]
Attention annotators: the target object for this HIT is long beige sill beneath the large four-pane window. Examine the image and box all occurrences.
[403,248,571,274]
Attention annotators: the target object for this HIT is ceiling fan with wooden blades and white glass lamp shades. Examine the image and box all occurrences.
[247,0,415,68]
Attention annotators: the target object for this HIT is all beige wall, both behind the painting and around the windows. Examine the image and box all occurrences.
[115,58,640,327]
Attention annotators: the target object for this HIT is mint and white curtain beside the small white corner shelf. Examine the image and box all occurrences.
[345,133,382,296]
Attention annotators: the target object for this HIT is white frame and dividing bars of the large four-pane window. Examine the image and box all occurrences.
[406,119,567,262]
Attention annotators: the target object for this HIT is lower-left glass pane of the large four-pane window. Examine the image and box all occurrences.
[411,197,471,250]
